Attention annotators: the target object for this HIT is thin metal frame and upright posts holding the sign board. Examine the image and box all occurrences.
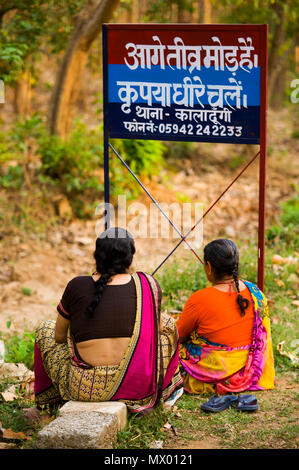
[102,23,268,290]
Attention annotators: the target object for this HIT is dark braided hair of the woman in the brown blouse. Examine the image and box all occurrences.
[86,228,135,316]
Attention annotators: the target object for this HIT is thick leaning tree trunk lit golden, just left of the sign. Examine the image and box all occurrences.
[48,0,120,137]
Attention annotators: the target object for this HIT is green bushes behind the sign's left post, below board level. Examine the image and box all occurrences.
[0,114,165,217]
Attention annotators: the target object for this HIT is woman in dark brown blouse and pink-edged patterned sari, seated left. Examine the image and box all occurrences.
[34,228,183,413]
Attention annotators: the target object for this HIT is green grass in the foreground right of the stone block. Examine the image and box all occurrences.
[117,375,298,449]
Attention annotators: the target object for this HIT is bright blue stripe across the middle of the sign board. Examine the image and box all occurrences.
[108,64,260,106]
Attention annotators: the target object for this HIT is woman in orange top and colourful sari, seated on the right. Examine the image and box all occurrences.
[177,239,275,394]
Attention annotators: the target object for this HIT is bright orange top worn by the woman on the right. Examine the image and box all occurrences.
[177,287,254,347]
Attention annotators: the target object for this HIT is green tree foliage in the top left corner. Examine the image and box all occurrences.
[0,0,85,85]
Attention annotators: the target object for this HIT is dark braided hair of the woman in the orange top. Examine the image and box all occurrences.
[204,238,249,316]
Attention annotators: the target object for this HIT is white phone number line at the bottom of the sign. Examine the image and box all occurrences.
[124,119,242,137]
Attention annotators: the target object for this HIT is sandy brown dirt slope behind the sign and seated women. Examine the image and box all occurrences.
[0,111,299,332]
